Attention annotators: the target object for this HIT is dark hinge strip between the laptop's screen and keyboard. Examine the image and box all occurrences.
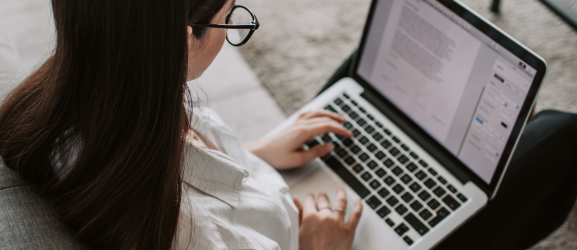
[361,90,471,185]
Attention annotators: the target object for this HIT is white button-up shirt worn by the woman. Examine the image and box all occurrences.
[173,102,298,250]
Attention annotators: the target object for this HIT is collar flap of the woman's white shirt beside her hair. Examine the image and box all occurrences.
[183,142,248,208]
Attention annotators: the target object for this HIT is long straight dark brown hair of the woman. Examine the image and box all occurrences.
[0,0,227,249]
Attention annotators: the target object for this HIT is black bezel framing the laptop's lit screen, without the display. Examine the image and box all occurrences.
[350,0,546,198]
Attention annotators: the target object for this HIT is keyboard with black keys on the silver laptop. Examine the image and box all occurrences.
[306,93,467,246]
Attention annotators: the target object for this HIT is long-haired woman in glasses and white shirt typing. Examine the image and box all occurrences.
[0,0,362,249]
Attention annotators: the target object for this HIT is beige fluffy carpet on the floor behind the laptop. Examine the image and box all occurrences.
[239,0,577,249]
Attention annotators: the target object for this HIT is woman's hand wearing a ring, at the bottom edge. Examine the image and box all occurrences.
[294,188,363,250]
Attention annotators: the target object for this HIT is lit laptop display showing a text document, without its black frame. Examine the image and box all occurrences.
[357,0,536,184]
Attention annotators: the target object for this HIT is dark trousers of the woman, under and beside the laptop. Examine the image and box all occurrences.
[321,54,577,249]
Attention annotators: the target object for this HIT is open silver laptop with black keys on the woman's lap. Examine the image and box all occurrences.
[270,0,546,249]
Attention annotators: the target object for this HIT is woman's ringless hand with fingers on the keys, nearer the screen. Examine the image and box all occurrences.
[244,110,352,169]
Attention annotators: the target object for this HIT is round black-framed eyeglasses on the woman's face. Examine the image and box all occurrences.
[190,5,260,46]
